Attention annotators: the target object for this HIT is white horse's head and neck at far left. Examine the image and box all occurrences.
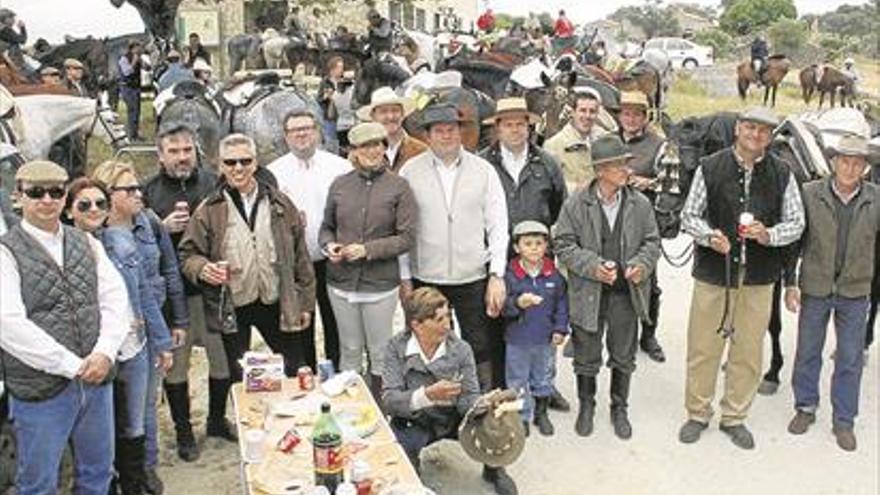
[6,95,127,160]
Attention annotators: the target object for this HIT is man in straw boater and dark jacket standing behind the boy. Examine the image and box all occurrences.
[480,97,570,411]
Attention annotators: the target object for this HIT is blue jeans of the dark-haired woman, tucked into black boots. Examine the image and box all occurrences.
[113,347,150,438]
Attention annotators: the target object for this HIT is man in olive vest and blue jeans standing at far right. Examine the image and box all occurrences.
[785,135,880,451]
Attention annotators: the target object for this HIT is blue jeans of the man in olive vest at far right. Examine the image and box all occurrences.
[791,295,868,427]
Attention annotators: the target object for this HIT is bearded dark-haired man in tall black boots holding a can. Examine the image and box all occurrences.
[144,123,236,493]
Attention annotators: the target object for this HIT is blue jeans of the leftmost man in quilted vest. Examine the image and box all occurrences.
[9,380,114,495]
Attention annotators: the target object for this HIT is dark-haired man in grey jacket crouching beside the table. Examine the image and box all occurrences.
[382,287,517,495]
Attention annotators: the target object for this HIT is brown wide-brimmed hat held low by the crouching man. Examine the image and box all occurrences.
[458,390,526,467]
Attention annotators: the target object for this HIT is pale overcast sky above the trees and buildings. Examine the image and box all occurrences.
[0,0,866,43]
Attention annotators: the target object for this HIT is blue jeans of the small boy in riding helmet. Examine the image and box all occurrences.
[506,344,556,421]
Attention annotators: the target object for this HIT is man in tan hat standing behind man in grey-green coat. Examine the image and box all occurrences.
[617,91,666,363]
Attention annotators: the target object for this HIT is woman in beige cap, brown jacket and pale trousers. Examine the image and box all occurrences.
[318,122,416,400]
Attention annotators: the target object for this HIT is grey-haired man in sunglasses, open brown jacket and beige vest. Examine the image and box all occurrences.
[180,134,315,381]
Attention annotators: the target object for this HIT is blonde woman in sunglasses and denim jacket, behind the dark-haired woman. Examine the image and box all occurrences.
[92,161,189,492]
